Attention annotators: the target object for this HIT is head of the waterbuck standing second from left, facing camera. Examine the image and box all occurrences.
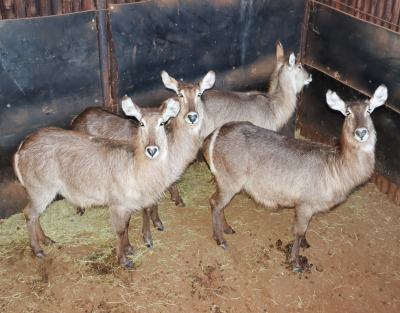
[161,71,215,130]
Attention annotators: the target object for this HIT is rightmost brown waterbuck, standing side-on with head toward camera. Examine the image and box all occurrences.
[203,85,387,272]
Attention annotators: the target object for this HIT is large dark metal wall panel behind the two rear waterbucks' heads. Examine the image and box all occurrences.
[110,0,304,112]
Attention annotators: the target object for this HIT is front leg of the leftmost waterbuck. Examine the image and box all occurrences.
[108,206,132,267]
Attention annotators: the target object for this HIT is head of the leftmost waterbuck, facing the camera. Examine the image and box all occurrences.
[122,96,180,159]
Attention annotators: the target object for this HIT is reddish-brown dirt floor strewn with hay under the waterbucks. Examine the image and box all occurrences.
[0,163,400,312]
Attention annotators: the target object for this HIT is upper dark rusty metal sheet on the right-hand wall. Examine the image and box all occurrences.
[305,2,400,112]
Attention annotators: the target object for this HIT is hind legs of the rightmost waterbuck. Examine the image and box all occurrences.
[210,188,235,250]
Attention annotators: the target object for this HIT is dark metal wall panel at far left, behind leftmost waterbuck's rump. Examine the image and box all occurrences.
[0,11,102,218]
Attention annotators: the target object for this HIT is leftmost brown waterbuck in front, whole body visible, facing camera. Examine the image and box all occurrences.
[13,97,180,267]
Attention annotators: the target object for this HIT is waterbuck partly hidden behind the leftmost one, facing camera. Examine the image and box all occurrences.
[71,71,215,248]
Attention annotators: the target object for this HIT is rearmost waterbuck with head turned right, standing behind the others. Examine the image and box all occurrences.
[162,41,312,140]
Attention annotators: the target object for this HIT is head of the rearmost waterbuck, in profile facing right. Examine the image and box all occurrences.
[270,41,312,94]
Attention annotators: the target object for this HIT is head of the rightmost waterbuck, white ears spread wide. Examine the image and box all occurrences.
[326,85,388,145]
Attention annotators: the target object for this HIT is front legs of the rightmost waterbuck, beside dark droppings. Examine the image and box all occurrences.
[290,206,313,273]
